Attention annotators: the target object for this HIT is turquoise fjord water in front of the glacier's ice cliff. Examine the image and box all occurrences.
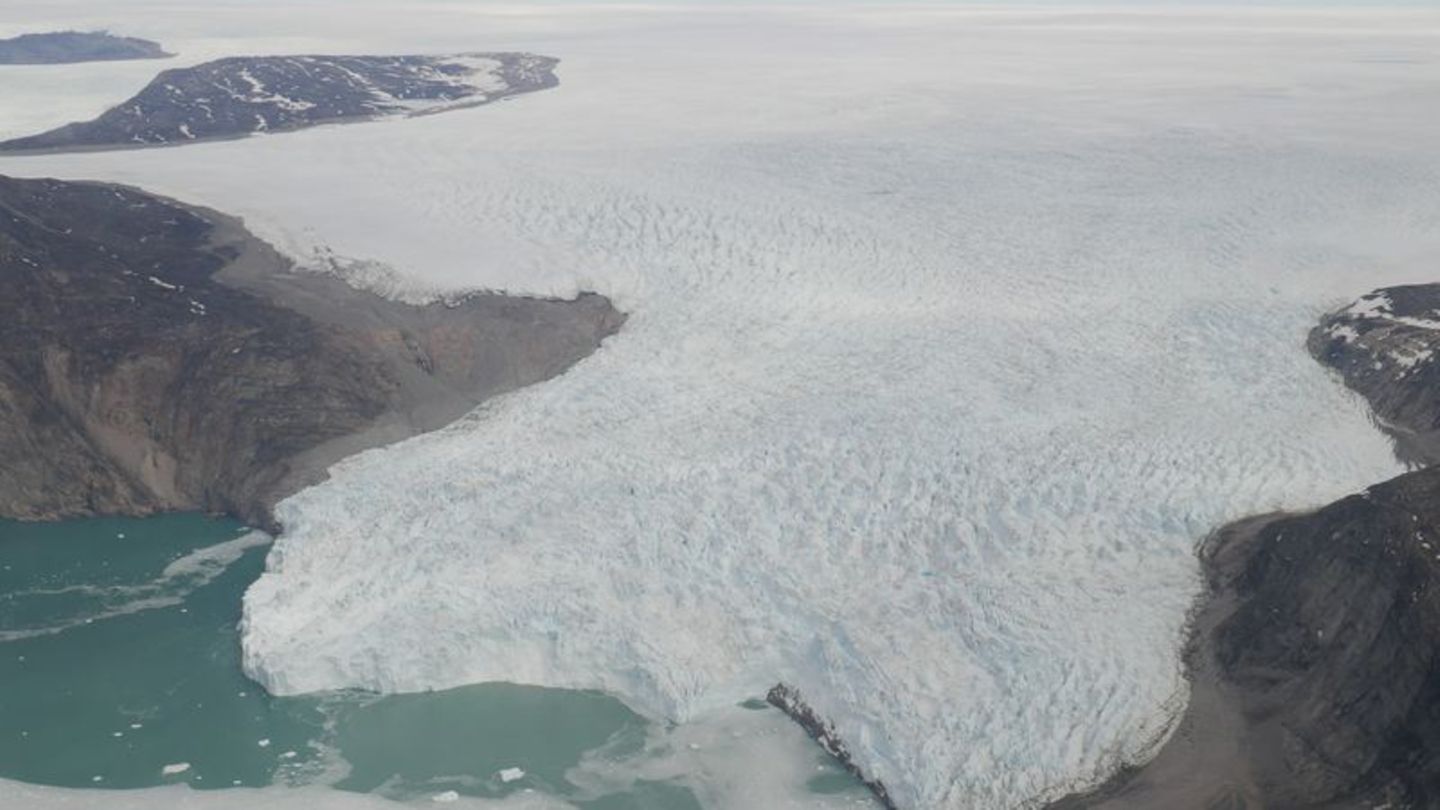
[0,515,864,810]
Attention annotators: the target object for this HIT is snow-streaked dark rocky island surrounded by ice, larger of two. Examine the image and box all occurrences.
[0,53,559,151]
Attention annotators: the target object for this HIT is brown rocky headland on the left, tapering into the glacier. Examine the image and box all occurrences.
[0,177,624,528]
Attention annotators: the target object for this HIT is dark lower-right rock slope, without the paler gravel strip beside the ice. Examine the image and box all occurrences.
[1210,468,1440,807]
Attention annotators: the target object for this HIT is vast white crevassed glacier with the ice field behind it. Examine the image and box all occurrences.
[0,0,1440,810]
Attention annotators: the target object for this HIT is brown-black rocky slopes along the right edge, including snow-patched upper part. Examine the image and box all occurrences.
[1053,285,1440,809]
